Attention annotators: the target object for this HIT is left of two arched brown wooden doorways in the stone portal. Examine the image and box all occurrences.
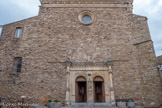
[75,76,87,103]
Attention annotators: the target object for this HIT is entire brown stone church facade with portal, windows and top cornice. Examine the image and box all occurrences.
[0,0,162,106]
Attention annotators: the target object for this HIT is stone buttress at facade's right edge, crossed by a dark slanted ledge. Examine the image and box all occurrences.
[133,15,162,105]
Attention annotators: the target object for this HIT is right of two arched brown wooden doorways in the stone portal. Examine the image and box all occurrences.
[93,76,105,103]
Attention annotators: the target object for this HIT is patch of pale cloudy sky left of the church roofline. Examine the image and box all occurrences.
[0,0,40,25]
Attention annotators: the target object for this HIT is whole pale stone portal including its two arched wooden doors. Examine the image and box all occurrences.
[65,61,115,105]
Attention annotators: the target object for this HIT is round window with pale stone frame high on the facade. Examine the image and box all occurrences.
[79,11,94,25]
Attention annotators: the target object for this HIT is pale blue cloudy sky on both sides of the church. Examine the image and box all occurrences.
[0,0,162,56]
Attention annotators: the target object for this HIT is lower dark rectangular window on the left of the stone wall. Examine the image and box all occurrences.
[13,57,22,73]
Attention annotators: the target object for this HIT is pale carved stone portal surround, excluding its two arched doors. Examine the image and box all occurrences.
[65,58,115,106]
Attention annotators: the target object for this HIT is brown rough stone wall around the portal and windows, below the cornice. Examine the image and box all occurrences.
[0,7,161,106]
